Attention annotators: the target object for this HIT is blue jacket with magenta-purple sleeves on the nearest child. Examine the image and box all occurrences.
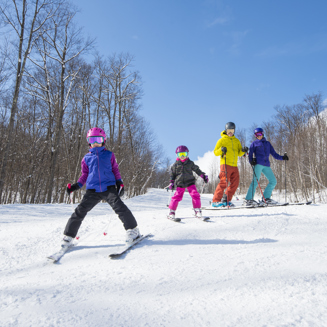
[78,146,121,192]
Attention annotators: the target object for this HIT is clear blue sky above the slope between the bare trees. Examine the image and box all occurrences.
[73,0,327,160]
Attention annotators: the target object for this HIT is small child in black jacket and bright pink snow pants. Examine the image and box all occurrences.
[167,145,209,220]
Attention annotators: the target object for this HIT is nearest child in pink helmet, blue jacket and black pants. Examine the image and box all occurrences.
[61,127,140,247]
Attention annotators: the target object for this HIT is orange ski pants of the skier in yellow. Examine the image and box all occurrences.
[212,165,240,202]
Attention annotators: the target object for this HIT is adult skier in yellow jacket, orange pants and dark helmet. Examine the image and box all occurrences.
[212,122,249,207]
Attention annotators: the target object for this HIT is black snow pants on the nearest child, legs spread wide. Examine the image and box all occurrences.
[64,185,137,238]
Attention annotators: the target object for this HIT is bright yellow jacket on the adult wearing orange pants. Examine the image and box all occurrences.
[213,131,245,167]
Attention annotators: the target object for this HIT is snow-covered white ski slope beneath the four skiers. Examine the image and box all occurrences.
[0,189,327,327]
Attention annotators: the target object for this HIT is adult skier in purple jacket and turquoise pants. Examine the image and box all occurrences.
[244,127,288,206]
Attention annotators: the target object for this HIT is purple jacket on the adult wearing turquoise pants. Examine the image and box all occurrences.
[249,137,283,167]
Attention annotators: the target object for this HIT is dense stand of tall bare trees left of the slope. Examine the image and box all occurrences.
[0,0,167,204]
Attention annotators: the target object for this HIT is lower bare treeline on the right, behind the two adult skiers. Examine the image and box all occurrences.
[200,93,327,202]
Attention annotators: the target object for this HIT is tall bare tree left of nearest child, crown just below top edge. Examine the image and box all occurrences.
[24,6,93,203]
